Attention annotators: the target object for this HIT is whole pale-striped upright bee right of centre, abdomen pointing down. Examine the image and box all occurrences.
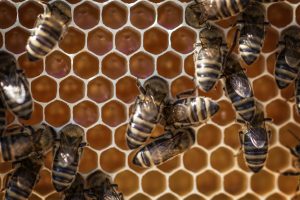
[194,25,224,92]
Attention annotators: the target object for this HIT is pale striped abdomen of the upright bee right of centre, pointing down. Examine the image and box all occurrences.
[196,59,222,92]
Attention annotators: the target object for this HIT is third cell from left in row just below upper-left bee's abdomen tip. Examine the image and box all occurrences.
[73,52,99,79]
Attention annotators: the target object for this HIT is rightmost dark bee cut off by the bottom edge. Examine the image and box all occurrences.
[85,170,124,200]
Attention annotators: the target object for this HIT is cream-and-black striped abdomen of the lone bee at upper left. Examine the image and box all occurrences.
[26,16,62,60]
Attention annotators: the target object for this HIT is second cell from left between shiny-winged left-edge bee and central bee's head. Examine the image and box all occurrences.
[59,76,85,103]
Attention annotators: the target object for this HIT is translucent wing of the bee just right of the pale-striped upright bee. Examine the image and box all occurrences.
[229,73,252,98]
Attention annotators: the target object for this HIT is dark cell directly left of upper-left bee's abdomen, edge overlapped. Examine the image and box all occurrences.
[5,27,30,54]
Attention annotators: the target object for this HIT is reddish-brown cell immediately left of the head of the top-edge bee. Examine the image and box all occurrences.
[157,2,183,29]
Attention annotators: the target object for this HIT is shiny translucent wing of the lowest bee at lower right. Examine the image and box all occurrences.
[248,127,267,148]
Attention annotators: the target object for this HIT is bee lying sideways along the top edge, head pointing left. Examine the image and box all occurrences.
[185,0,252,28]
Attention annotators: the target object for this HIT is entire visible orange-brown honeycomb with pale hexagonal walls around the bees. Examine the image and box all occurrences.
[0,0,300,200]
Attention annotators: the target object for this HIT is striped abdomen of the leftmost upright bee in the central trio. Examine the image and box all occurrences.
[126,113,156,149]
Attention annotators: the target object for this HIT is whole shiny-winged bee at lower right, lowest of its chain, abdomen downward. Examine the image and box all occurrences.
[239,105,271,173]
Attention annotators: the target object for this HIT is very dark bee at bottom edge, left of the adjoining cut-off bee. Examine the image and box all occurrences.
[63,173,86,200]
